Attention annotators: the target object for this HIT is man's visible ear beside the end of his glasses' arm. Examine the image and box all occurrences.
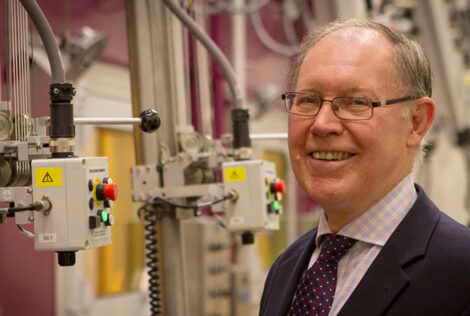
[406,97,436,147]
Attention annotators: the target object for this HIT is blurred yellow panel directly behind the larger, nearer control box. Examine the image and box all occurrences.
[78,129,144,295]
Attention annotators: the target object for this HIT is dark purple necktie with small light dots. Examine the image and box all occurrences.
[290,234,356,316]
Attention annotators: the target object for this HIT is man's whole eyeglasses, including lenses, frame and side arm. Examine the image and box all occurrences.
[282,92,413,121]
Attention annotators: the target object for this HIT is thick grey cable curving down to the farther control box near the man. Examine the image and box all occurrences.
[163,0,245,109]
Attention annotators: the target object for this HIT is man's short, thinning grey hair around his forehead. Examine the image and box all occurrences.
[288,19,432,98]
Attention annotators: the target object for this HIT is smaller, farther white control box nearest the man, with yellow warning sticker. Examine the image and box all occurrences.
[223,160,281,232]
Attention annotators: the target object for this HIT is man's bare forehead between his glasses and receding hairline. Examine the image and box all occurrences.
[296,28,394,97]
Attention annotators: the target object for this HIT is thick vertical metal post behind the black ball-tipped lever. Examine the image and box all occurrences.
[126,0,190,315]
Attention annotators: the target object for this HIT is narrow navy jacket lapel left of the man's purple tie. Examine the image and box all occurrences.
[265,228,317,316]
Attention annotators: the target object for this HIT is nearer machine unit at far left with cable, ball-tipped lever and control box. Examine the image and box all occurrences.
[0,0,160,266]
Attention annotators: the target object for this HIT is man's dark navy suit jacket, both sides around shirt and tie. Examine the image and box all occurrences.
[260,186,470,316]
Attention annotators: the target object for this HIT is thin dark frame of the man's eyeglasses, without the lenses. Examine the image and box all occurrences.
[281,91,416,121]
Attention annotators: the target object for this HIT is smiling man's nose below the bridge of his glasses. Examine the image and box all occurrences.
[310,100,344,136]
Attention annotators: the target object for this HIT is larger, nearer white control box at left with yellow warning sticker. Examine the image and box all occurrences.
[31,157,113,251]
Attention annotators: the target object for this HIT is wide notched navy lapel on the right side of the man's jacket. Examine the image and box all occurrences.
[339,186,439,315]
